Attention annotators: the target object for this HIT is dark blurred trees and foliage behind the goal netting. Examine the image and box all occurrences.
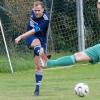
[0,0,100,54]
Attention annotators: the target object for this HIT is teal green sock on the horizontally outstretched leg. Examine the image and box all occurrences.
[47,55,76,67]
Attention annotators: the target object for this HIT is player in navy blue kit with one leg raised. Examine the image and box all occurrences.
[15,0,49,96]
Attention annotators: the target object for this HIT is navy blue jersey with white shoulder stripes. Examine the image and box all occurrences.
[26,10,49,45]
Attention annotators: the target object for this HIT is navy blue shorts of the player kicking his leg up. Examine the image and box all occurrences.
[26,35,46,53]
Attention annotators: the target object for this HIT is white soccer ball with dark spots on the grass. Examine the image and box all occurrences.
[74,83,89,97]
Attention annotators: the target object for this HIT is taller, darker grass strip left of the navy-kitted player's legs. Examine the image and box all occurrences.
[0,53,34,72]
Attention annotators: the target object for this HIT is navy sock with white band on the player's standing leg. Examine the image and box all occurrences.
[35,72,42,91]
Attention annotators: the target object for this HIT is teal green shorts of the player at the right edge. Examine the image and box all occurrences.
[84,44,100,64]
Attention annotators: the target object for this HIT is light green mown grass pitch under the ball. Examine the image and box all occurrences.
[0,64,100,100]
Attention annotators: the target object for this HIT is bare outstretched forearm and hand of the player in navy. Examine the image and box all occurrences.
[15,29,35,44]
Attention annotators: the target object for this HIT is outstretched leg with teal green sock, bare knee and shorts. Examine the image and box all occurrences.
[47,44,100,68]
